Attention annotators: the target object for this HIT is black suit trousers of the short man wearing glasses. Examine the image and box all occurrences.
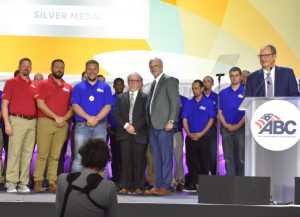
[120,136,148,189]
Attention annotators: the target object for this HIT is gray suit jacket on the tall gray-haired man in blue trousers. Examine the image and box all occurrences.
[147,74,180,129]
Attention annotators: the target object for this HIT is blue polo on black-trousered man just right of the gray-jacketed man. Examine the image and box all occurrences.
[182,96,216,133]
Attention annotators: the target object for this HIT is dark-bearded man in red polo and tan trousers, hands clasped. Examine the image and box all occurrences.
[34,59,72,192]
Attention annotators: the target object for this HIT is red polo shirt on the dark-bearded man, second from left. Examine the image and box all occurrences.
[35,76,72,117]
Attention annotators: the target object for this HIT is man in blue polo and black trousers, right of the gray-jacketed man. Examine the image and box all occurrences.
[182,80,216,191]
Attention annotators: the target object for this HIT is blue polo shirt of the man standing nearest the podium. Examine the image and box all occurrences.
[220,85,245,124]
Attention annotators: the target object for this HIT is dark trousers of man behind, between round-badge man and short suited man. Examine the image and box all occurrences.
[109,129,122,183]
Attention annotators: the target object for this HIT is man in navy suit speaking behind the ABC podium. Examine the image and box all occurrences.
[245,44,299,97]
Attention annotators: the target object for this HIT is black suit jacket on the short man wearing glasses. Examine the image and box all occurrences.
[114,90,148,144]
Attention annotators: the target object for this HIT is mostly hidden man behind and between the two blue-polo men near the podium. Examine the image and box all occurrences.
[203,76,218,175]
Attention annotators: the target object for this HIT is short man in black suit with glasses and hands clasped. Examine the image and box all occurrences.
[114,72,148,195]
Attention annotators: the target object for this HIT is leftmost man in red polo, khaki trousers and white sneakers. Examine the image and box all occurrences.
[2,58,36,193]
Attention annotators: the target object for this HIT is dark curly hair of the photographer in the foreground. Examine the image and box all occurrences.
[78,139,110,170]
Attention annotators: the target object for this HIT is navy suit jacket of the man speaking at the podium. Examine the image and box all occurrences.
[245,66,300,97]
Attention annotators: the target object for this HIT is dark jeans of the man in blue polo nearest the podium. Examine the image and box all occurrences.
[221,125,245,176]
